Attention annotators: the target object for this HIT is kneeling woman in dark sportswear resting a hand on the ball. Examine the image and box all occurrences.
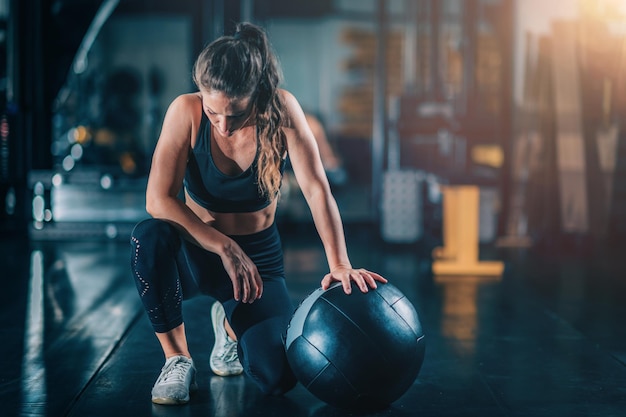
[131,23,386,404]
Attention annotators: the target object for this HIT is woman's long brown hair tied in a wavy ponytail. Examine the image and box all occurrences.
[193,23,286,199]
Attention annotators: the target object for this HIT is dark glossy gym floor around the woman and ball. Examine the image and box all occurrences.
[0,219,626,417]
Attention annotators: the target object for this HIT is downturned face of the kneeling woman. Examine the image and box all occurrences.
[201,91,254,137]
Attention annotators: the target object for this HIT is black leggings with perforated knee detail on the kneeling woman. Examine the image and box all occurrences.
[131,219,296,395]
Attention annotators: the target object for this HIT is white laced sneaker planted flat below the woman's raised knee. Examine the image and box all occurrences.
[152,356,198,404]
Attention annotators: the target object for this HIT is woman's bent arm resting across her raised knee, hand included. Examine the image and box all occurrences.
[146,94,263,302]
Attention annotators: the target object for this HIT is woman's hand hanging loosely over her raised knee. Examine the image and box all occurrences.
[221,242,263,303]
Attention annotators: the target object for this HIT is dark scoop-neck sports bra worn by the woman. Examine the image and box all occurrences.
[183,111,285,213]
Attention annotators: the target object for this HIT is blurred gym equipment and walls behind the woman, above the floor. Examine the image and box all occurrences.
[0,0,626,250]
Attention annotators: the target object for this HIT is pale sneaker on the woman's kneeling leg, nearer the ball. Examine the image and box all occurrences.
[210,302,243,376]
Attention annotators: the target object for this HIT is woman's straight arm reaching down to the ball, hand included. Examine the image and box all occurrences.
[281,90,387,294]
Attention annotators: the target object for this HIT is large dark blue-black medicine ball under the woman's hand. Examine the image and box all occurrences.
[285,283,425,409]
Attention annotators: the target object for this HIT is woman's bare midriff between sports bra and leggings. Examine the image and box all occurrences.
[185,193,276,236]
